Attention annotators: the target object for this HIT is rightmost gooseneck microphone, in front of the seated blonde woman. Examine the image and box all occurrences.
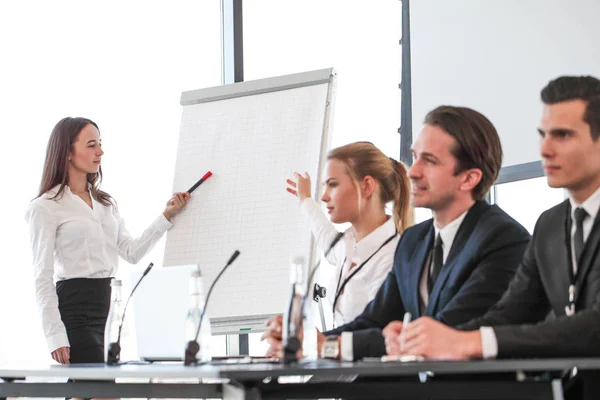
[283,232,344,364]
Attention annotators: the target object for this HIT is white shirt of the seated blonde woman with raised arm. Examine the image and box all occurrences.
[301,198,400,327]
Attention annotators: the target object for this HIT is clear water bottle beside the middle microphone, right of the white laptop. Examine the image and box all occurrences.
[185,270,211,362]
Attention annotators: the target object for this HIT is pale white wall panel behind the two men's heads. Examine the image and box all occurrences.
[410,0,600,166]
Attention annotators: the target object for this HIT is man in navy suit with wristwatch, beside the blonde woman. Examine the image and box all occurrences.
[263,106,530,359]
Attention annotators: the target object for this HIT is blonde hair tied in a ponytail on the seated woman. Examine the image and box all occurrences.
[327,142,414,233]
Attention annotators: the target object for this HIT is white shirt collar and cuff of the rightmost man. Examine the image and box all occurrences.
[479,188,600,359]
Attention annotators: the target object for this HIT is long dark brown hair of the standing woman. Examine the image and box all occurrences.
[36,117,115,206]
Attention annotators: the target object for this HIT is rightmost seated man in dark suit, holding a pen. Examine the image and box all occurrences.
[384,76,600,366]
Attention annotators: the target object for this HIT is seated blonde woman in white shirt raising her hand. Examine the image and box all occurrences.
[287,142,413,327]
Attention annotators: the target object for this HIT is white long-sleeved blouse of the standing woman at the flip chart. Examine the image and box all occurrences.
[25,186,171,352]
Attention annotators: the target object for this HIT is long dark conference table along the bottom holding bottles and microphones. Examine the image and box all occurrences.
[0,358,600,400]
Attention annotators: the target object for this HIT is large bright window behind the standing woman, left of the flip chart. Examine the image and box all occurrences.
[0,0,221,362]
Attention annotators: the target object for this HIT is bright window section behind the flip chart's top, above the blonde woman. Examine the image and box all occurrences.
[243,0,402,159]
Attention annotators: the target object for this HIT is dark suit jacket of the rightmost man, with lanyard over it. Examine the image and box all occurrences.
[459,200,600,357]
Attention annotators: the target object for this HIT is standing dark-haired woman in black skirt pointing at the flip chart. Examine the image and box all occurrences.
[26,117,190,364]
